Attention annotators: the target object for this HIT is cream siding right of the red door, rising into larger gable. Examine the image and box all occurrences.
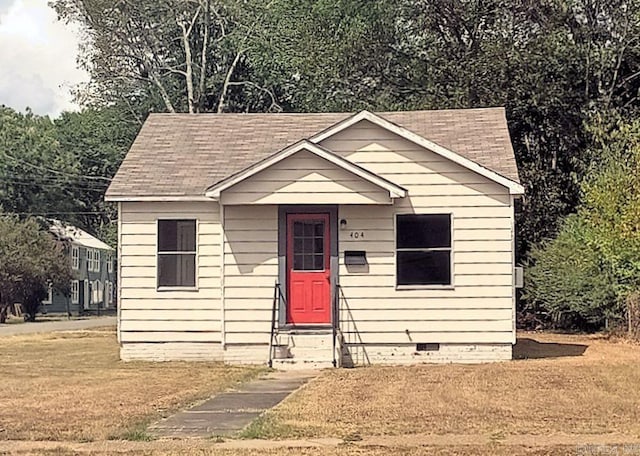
[322,122,515,344]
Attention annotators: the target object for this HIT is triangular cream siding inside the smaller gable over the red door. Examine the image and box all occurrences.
[220,151,391,205]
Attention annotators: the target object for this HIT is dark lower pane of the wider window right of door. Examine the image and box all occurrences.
[397,251,451,285]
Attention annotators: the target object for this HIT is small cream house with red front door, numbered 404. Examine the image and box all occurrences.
[106,108,523,367]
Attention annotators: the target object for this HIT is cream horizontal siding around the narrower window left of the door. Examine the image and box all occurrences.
[119,202,222,346]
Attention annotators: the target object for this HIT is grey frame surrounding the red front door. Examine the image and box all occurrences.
[278,204,339,328]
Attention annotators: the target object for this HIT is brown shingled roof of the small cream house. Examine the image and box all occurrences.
[106,108,519,199]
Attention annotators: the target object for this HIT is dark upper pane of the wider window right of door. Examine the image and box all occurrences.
[396,214,451,249]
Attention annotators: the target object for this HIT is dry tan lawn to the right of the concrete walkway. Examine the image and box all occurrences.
[257,334,640,440]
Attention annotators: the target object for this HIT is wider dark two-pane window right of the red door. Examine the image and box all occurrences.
[396,214,451,285]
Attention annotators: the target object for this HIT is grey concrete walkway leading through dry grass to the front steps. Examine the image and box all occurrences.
[148,370,319,438]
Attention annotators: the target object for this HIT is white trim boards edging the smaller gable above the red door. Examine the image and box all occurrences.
[206,139,407,199]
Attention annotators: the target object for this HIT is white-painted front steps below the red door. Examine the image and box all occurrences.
[273,330,340,370]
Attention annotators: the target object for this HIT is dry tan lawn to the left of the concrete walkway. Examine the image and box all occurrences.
[0,328,260,442]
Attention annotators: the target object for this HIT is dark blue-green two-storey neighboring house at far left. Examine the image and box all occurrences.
[40,220,117,314]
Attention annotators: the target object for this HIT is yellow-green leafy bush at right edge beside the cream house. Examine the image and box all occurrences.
[524,114,640,324]
